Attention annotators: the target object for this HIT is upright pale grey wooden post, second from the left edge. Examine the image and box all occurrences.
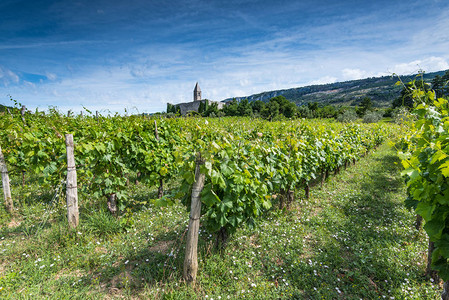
[65,134,79,228]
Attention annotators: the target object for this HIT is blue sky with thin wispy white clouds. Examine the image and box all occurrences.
[0,0,449,113]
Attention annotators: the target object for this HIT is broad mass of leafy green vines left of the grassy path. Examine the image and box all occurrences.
[0,110,394,284]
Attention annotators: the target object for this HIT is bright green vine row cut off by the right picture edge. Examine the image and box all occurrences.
[398,83,449,299]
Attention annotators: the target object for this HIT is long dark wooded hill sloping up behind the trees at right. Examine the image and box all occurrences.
[223,71,445,107]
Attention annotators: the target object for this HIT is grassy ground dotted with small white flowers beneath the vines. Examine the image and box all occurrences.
[0,145,440,299]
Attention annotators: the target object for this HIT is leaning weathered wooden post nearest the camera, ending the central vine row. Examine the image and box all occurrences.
[183,153,206,284]
